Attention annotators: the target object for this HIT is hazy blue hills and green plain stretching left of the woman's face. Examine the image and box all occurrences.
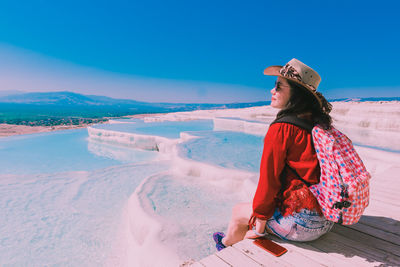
[0,92,269,125]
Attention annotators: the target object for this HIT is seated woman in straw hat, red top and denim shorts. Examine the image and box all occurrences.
[213,59,333,250]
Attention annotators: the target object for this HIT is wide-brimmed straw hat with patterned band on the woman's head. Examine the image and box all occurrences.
[264,58,322,106]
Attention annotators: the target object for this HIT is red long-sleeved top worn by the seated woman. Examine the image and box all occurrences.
[252,123,321,221]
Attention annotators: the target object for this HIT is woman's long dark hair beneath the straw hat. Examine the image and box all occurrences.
[276,80,332,129]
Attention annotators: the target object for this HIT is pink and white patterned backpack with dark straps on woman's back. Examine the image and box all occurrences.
[274,116,371,225]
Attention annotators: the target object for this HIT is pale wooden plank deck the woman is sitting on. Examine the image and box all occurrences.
[191,149,400,267]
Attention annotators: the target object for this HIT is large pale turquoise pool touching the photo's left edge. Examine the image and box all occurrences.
[0,129,157,174]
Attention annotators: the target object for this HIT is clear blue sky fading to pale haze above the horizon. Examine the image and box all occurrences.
[0,0,400,103]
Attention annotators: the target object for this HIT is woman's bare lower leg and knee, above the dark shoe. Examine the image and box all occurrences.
[222,203,253,246]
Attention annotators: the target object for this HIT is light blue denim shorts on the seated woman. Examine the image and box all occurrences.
[267,209,334,241]
